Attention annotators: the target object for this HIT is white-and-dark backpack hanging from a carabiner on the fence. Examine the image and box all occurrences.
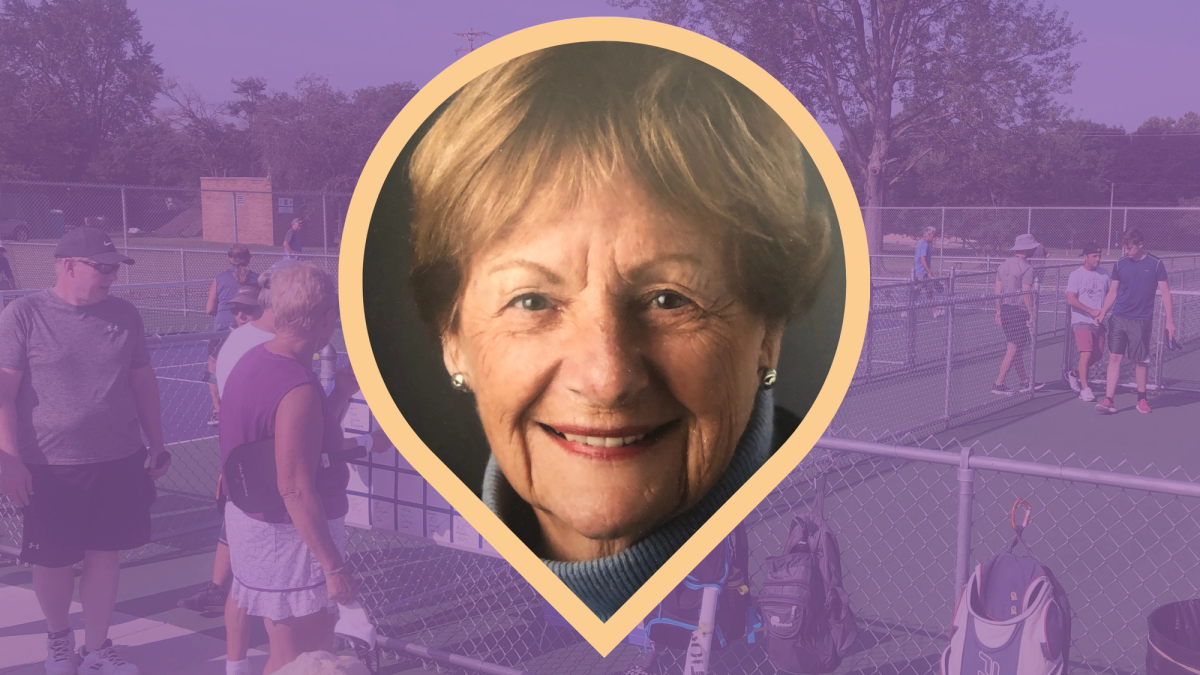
[942,500,1070,675]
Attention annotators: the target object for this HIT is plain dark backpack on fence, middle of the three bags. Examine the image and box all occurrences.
[758,476,858,674]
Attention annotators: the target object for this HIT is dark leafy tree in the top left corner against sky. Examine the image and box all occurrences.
[0,0,162,180]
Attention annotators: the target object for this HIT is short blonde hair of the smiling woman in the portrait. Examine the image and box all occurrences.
[408,42,830,334]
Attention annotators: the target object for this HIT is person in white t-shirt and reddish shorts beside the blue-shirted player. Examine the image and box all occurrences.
[1067,241,1112,401]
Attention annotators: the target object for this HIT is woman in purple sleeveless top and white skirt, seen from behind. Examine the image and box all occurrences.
[220,264,388,675]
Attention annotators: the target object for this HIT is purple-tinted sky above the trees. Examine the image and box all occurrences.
[128,0,1200,142]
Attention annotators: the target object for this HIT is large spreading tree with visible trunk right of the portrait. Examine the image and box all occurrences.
[610,0,1080,252]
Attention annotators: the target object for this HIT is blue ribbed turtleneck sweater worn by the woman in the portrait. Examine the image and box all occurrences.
[484,389,775,621]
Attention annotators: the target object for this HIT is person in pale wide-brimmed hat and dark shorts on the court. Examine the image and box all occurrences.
[991,234,1045,396]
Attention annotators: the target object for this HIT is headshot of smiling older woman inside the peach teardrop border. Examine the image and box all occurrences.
[362,42,846,620]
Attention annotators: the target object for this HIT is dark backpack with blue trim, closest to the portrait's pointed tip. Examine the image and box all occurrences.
[646,522,754,650]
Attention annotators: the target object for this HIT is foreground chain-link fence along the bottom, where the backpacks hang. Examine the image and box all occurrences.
[324,427,1200,674]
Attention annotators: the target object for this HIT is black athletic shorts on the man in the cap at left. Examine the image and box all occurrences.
[20,448,155,567]
